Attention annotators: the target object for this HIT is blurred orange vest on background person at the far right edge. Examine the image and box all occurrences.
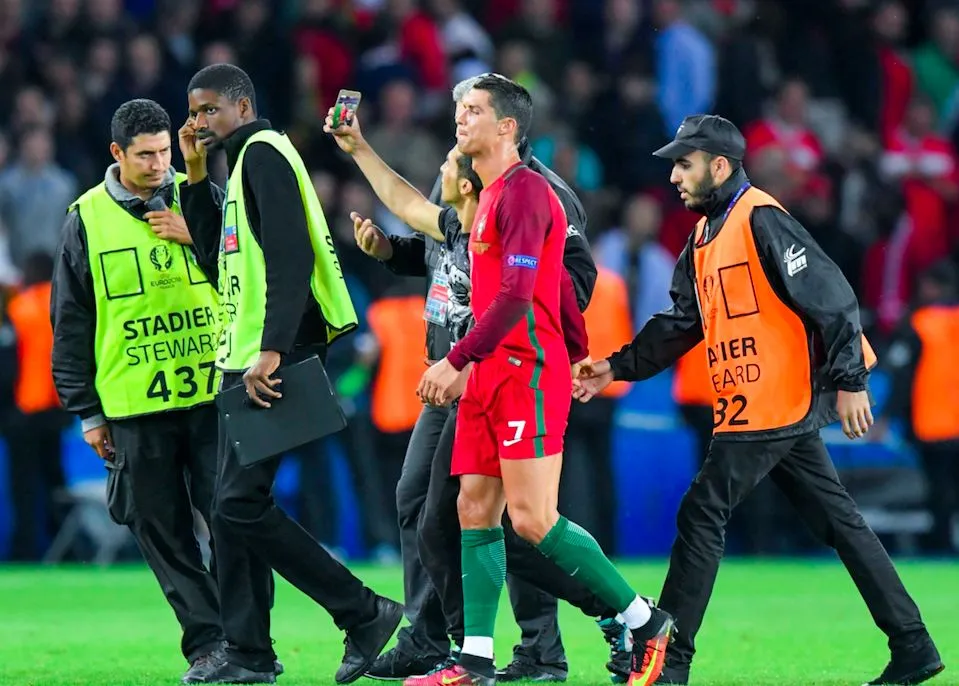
[912,305,959,442]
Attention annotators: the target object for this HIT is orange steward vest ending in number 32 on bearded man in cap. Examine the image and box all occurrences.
[693,187,876,434]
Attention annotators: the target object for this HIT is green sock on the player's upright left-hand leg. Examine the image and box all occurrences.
[461,526,506,644]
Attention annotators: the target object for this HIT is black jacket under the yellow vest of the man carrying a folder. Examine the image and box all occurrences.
[180,119,326,355]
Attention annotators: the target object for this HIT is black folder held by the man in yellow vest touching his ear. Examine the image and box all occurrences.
[216,355,346,467]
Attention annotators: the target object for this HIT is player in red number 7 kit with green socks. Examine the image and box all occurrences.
[417,76,673,686]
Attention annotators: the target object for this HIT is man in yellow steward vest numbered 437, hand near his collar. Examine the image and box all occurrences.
[51,100,222,679]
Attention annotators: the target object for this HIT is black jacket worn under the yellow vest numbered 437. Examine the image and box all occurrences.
[50,165,216,419]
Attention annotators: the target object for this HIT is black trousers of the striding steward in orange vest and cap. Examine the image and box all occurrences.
[659,433,925,670]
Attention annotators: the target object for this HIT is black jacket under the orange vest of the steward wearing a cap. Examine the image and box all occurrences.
[609,170,869,440]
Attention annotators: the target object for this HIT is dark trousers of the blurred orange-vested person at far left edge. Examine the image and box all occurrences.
[4,410,69,562]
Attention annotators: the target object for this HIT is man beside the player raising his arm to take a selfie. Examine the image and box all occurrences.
[324,108,631,684]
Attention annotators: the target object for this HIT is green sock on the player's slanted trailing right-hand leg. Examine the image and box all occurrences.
[540,516,636,612]
